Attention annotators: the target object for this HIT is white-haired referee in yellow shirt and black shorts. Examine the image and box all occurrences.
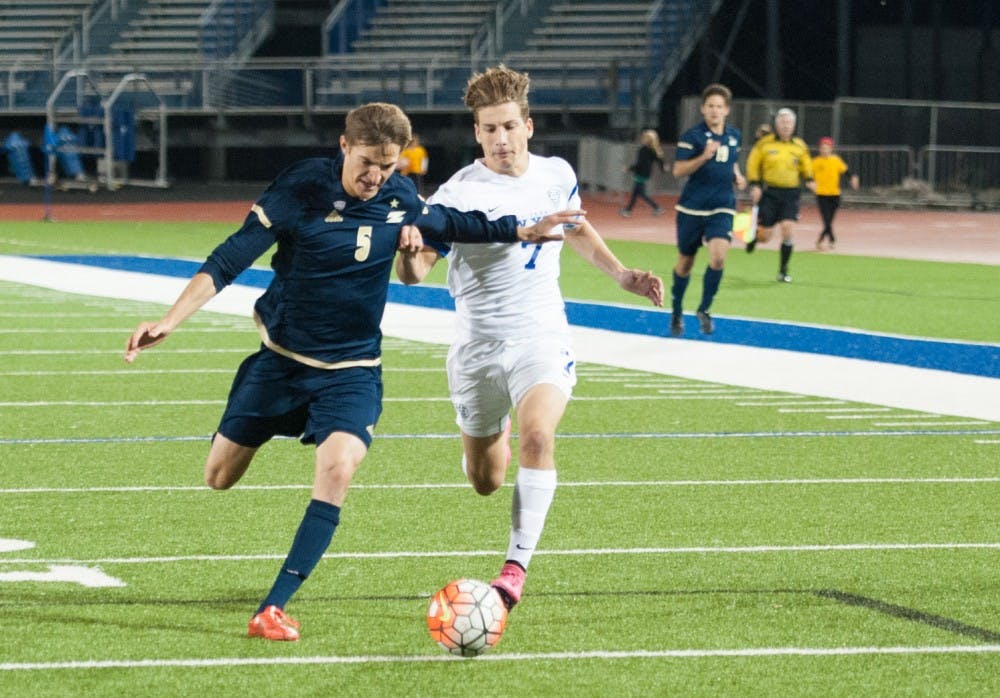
[747,109,816,283]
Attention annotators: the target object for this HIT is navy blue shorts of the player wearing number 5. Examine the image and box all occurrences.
[219,348,382,448]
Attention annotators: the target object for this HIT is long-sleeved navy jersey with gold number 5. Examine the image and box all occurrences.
[200,154,517,368]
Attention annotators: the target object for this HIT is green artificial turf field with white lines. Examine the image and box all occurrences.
[0,224,1000,697]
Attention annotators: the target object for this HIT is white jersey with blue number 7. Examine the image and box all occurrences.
[428,155,580,342]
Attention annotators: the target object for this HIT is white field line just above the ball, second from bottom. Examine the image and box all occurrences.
[0,543,1000,565]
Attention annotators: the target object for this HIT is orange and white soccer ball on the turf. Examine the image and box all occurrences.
[427,579,507,657]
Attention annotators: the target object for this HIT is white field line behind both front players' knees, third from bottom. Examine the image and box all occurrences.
[0,474,1000,496]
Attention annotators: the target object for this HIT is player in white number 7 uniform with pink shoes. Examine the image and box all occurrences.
[396,65,663,608]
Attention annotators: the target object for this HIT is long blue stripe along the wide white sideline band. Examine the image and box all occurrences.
[38,255,1000,378]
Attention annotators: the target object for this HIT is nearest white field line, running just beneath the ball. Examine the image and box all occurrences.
[0,645,1000,671]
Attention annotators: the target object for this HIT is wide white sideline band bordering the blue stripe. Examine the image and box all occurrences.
[0,255,1000,421]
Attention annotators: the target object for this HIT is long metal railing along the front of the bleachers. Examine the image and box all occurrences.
[0,56,644,114]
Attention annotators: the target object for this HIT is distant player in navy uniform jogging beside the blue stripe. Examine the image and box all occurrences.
[670,84,746,337]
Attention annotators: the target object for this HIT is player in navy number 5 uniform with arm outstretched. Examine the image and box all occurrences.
[125,103,583,640]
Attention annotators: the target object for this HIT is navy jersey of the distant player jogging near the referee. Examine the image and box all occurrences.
[676,122,742,216]
